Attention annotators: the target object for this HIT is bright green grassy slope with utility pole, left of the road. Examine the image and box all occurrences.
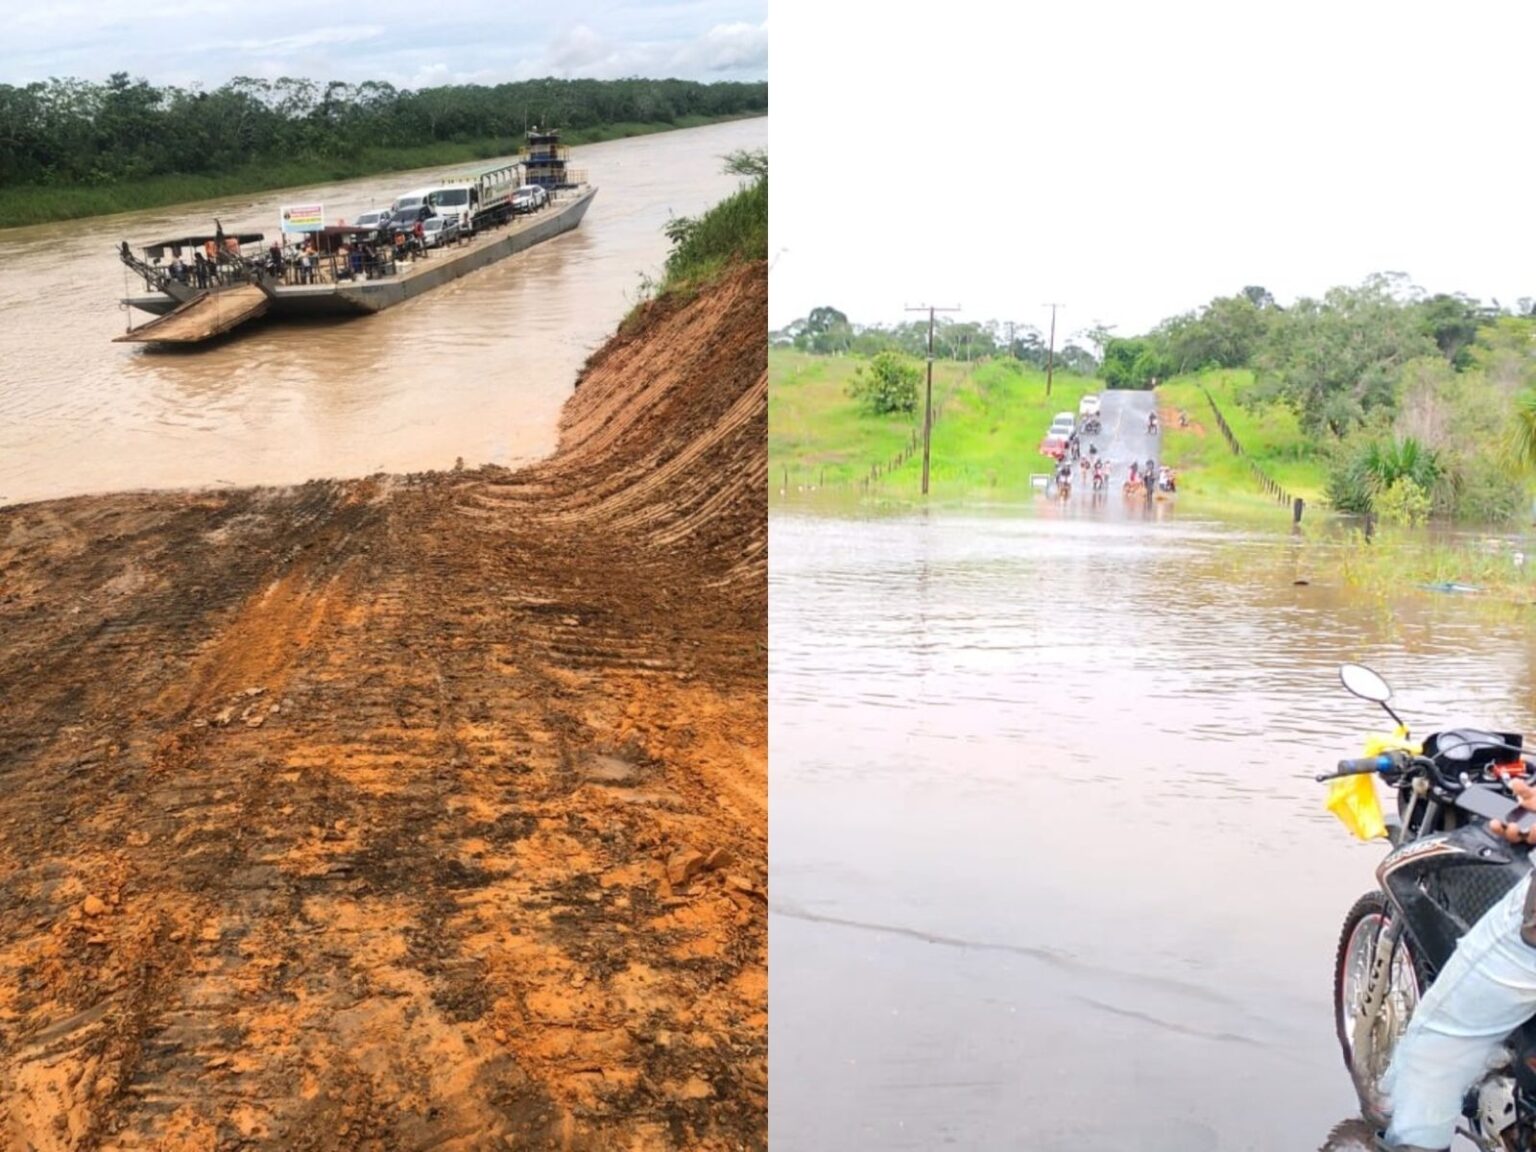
[768,349,1100,499]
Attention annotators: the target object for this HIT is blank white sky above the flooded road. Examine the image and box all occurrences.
[770,0,1536,339]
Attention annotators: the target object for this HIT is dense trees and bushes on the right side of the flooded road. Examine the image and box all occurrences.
[1103,275,1536,522]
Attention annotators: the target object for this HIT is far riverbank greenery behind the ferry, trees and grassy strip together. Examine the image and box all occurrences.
[0,72,768,226]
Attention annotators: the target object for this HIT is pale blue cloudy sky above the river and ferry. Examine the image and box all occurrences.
[0,0,768,88]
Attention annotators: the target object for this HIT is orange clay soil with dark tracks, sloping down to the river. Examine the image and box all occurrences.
[0,264,768,1152]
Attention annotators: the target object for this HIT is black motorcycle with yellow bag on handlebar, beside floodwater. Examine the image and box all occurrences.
[1316,664,1536,1152]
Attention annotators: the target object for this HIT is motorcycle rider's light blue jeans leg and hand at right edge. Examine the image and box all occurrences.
[1381,780,1536,1152]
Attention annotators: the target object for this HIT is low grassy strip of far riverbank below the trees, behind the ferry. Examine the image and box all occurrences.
[0,114,768,227]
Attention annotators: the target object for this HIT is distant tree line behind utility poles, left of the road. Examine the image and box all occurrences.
[770,307,1098,376]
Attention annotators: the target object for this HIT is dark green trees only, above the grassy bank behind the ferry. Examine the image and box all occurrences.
[0,72,768,187]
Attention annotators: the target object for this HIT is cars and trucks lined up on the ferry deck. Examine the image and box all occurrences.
[353,163,550,247]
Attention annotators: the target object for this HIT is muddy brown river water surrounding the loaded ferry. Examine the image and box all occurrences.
[0,118,768,504]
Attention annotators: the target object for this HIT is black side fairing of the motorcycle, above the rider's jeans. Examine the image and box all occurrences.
[1376,820,1531,972]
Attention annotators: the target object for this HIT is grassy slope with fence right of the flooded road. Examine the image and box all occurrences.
[1157,369,1327,507]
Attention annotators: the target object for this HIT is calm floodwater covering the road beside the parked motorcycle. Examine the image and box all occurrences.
[770,498,1536,1152]
